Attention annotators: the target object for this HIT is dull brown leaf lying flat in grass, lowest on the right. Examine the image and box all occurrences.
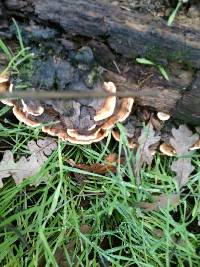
[136,193,180,211]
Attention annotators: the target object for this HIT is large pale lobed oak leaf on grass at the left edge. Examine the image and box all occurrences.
[0,138,57,187]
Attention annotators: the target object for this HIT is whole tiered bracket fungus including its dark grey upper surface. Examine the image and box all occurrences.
[0,48,134,144]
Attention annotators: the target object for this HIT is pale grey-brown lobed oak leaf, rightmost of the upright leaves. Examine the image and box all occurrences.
[170,125,199,188]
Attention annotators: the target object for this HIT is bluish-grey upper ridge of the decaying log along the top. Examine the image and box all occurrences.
[4,0,200,67]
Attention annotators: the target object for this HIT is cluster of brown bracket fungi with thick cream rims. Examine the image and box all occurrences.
[0,78,134,144]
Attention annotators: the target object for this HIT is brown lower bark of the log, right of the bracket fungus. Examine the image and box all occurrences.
[104,70,200,125]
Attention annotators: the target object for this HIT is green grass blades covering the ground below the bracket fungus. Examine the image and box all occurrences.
[0,118,200,266]
